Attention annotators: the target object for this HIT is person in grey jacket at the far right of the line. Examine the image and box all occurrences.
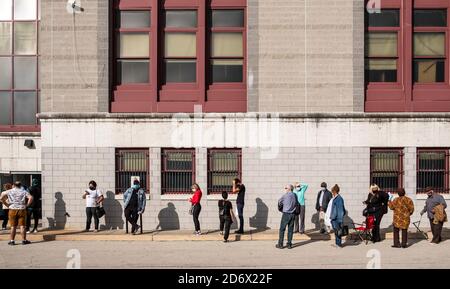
[420,187,447,244]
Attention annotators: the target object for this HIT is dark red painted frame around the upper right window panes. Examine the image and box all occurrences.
[365,0,450,112]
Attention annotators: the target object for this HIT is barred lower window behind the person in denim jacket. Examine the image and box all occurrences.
[116,149,150,194]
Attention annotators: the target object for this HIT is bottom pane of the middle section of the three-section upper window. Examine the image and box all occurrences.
[165,59,197,83]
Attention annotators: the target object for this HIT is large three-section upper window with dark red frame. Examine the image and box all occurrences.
[111,0,247,112]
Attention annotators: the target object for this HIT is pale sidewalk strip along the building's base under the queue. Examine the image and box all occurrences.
[0,230,442,242]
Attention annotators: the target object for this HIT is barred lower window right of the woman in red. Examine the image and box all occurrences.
[208,149,242,194]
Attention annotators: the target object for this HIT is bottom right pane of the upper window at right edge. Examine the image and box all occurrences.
[414,59,445,83]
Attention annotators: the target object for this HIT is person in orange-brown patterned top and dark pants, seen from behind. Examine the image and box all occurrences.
[388,188,414,248]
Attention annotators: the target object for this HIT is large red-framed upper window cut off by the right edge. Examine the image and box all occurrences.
[365,0,450,112]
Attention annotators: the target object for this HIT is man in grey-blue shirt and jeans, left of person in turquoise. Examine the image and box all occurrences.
[275,185,297,249]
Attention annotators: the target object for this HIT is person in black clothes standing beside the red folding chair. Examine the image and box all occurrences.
[363,184,389,243]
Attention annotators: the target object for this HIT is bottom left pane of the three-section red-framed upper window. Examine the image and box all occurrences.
[117,60,149,84]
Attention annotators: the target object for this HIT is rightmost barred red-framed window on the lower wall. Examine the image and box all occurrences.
[417,148,450,194]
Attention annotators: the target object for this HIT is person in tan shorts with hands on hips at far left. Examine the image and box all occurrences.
[0,181,33,246]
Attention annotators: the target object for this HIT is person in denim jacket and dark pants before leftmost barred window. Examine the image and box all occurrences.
[123,180,146,235]
